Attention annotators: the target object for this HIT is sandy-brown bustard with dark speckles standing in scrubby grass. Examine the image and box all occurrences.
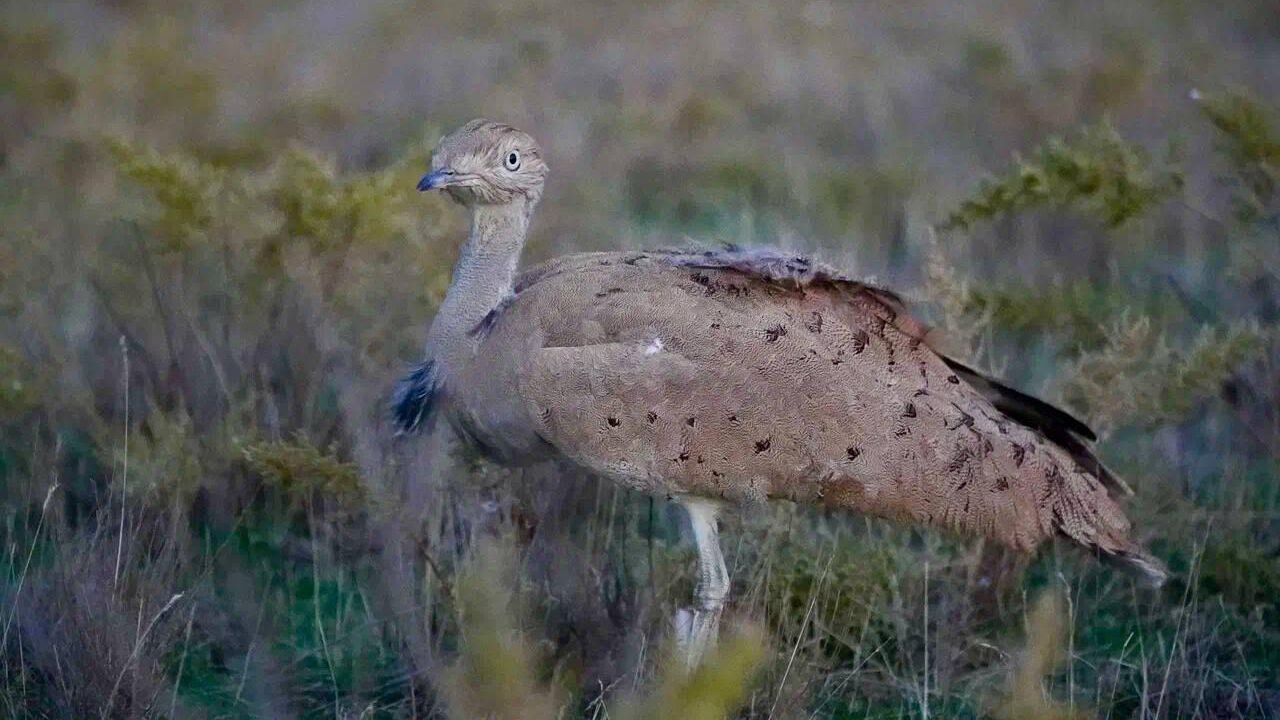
[393,119,1165,661]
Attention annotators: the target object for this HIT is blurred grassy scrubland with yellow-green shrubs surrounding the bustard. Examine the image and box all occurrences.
[0,0,1280,719]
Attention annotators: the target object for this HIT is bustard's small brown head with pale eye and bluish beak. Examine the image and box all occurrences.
[417,119,547,206]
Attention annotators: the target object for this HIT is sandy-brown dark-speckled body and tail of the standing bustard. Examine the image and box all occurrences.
[460,245,1162,584]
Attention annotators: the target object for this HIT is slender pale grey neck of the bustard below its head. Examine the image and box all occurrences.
[426,199,530,366]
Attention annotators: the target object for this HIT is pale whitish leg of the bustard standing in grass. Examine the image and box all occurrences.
[676,498,730,667]
